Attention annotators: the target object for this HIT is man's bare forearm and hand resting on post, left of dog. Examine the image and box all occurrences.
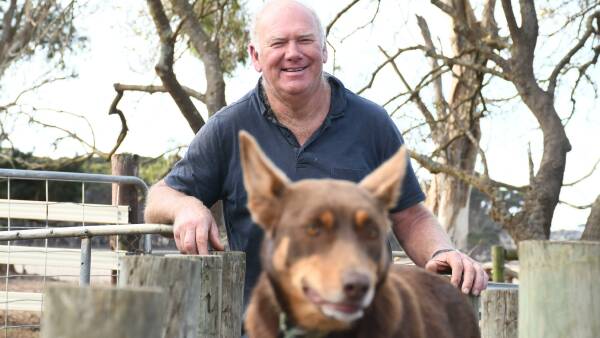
[144,180,224,254]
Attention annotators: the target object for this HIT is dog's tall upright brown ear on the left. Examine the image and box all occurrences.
[239,130,289,230]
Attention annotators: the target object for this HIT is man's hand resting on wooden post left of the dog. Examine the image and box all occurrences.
[173,201,225,255]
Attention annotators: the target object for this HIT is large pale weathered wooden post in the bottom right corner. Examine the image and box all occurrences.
[519,241,600,338]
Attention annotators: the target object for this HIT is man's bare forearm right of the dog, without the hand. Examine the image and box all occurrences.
[390,204,454,266]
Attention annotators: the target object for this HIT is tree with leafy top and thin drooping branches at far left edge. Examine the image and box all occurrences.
[0,0,96,169]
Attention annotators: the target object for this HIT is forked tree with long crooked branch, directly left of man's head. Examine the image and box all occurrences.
[110,0,249,153]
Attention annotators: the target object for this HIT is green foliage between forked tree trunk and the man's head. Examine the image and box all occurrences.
[194,0,250,75]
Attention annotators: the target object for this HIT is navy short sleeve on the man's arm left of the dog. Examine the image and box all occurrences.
[165,116,224,207]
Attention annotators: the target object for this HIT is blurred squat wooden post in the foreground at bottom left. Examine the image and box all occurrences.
[41,286,167,338]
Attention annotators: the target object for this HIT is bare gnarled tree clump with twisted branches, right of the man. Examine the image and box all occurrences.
[330,0,600,245]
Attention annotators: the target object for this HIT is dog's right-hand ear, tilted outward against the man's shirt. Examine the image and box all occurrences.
[359,146,407,209]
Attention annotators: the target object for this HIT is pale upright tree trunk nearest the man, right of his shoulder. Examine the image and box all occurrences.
[426,0,487,249]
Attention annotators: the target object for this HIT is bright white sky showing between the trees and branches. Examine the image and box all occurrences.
[0,0,600,229]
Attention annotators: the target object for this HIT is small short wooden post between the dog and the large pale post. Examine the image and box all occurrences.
[480,288,519,338]
